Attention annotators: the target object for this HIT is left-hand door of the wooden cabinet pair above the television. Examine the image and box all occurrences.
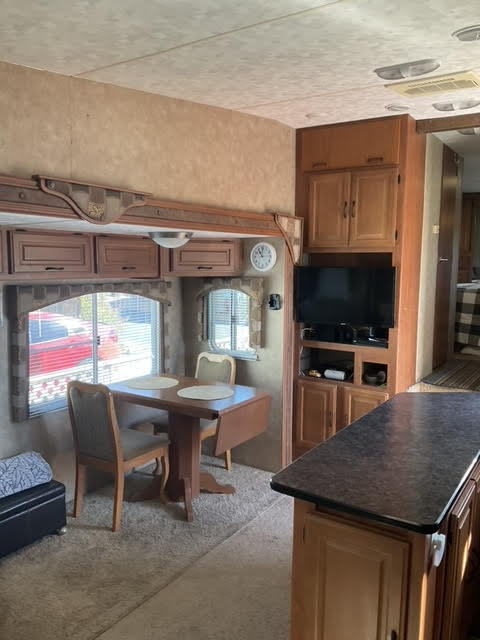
[307,171,350,249]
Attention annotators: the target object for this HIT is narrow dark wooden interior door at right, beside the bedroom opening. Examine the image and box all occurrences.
[432,146,461,369]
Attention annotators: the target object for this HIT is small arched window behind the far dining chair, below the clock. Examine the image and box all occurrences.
[207,289,256,358]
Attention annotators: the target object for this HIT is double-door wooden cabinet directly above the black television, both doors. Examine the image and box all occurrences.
[307,168,398,251]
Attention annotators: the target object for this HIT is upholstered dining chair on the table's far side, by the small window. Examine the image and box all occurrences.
[153,351,236,471]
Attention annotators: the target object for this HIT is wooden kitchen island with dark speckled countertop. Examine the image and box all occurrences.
[271,393,480,640]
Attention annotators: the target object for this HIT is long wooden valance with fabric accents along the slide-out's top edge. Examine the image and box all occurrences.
[0,176,303,263]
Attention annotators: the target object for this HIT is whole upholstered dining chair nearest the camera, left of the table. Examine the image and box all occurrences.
[67,380,169,531]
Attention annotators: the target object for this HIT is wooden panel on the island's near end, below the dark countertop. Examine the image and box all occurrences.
[290,513,409,640]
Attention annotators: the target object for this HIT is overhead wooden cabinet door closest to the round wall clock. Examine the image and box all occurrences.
[169,240,242,277]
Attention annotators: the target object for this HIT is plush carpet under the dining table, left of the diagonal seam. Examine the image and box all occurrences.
[0,458,282,640]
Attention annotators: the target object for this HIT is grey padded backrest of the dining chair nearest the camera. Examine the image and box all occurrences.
[67,380,122,462]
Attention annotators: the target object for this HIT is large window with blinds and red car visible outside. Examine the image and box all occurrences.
[28,293,161,416]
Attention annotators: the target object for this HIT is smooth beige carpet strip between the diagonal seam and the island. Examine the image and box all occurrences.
[98,496,293,640]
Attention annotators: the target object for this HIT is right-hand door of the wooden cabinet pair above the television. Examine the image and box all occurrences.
[349,169,398,249]
